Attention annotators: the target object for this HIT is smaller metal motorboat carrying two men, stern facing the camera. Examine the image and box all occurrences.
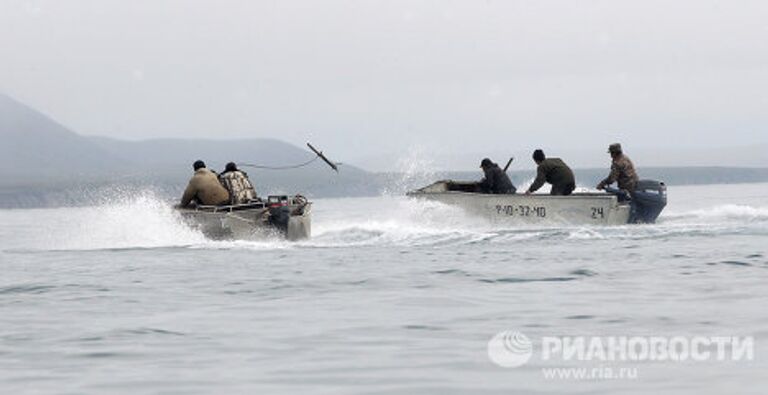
[178,195,312,241]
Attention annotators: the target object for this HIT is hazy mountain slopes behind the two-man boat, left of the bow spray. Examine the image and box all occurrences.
[0,94,375,206]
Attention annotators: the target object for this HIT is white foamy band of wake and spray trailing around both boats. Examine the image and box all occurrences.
[13,191,768,251]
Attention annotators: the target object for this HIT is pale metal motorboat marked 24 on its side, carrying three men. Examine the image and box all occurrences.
[408,180,667,225]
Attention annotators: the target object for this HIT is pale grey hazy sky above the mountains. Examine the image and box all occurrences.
[0,0,768,168]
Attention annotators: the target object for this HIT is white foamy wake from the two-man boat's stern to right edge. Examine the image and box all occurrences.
[302,198,768,247]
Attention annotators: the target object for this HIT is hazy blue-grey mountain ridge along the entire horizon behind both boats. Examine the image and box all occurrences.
[0,94,768,207]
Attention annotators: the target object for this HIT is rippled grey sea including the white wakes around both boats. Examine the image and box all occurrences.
[0,184,768,394]
